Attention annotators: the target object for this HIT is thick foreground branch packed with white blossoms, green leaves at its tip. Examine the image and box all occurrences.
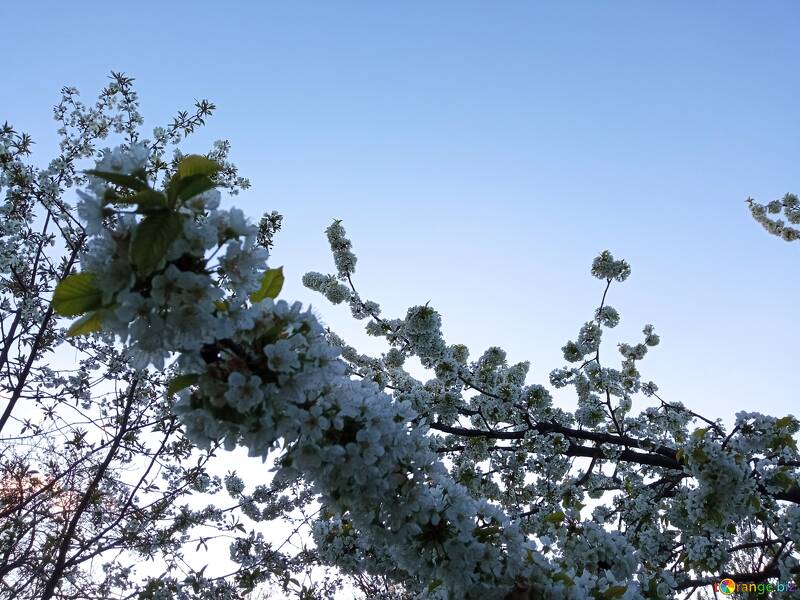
[69,148,612,598]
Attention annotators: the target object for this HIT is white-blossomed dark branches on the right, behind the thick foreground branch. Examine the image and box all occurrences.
[305,222,799,598]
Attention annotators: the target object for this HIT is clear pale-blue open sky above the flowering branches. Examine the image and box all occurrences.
[0,1,800,420]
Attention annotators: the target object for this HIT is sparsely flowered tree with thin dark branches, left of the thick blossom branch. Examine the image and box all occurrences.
[0,74,340,599]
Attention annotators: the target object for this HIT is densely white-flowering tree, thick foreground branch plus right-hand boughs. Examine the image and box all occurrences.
[1,76,800,599]
